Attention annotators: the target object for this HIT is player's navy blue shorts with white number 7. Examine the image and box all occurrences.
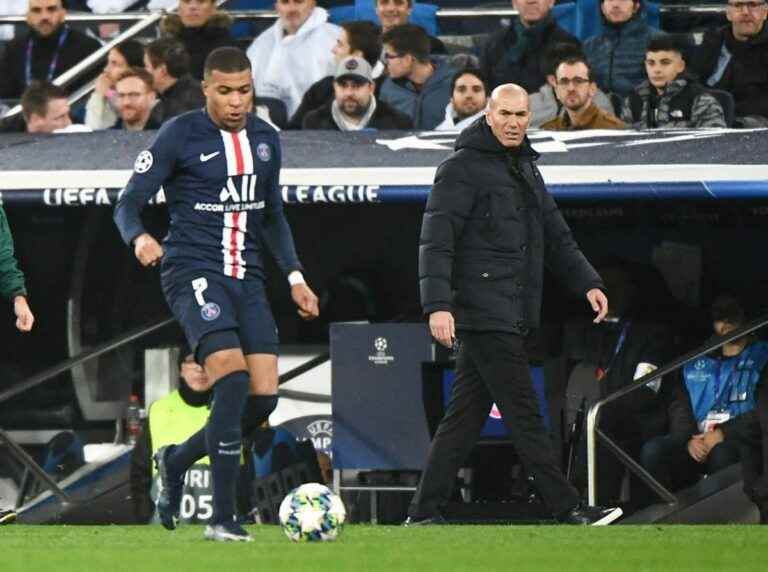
[163,272,278,363]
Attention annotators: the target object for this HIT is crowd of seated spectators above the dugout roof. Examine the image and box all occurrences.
[0,0,768,130]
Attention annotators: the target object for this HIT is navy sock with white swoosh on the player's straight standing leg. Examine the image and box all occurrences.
[205,371,250,524]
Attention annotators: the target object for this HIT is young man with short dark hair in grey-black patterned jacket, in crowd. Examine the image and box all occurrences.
[621,36,725,129]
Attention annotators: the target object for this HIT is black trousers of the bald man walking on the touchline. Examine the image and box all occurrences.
[408,331,579,518]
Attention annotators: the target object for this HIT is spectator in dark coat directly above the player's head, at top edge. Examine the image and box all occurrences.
[160,0,236,81]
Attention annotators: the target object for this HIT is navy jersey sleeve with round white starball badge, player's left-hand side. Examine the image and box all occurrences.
[113,121,181,245]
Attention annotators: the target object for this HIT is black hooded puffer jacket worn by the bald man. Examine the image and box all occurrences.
[419,118,604,335]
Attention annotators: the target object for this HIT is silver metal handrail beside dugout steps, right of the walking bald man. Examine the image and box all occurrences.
[587,314,768,506]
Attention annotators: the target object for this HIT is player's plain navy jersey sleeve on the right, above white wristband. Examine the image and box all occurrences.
[262,135,303,276]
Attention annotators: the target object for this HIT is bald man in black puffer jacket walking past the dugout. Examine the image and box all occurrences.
[406,84,621,524]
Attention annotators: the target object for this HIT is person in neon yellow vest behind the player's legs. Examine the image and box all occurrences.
[130,354,211,523]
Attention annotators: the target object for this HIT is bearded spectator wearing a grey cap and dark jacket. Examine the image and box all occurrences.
[303,56,412,131]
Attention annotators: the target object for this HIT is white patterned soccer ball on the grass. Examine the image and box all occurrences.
[280,483,347,542]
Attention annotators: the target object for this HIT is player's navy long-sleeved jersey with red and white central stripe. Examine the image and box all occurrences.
[114,110,301,279]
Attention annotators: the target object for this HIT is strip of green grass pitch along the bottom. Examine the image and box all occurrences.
[0,524,768,572]
